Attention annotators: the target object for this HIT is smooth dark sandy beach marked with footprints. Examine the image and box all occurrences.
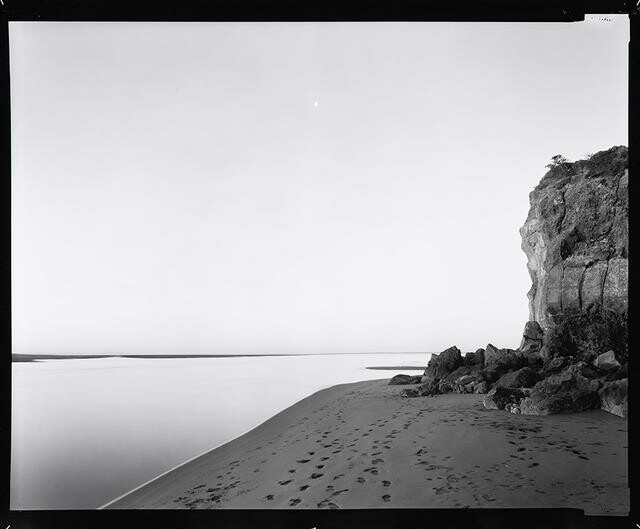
[107,379,629,515]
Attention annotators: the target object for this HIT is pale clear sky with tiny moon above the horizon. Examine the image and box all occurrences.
[9,16,629,354]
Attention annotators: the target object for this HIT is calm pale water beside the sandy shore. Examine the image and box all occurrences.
[10,353,428,509]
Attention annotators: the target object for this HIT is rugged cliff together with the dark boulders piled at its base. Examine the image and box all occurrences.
[391,147,629,417]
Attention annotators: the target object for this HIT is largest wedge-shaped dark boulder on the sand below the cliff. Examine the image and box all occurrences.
[520,362,600,415]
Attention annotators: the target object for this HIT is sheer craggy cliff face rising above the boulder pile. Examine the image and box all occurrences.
[520,146,629,360]
